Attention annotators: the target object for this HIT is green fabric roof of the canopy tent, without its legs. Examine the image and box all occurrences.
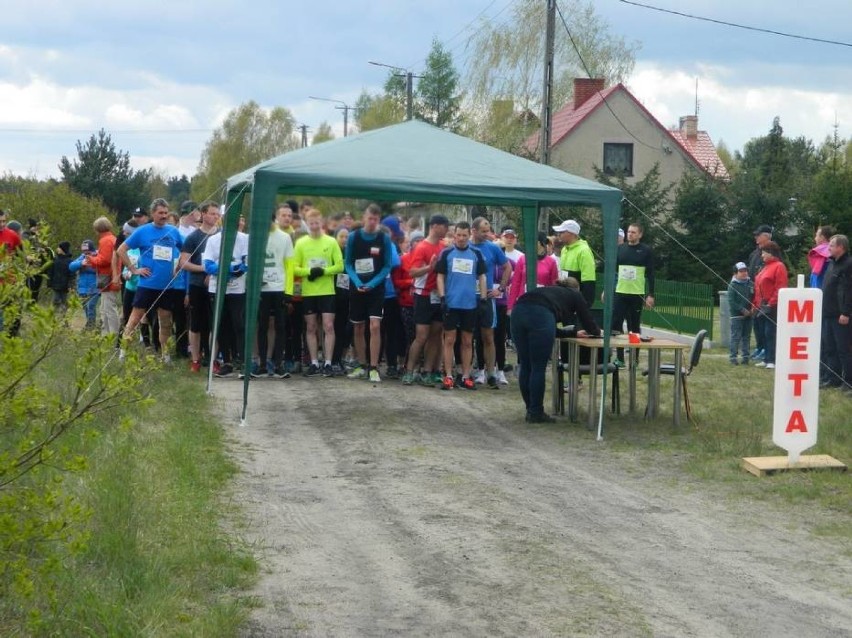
[228,120,621,206]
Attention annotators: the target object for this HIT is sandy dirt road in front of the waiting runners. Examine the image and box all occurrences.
[215,378,852,637]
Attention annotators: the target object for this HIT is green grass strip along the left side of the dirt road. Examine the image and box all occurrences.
[0,344,257,636]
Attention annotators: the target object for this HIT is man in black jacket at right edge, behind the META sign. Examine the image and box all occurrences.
[820,235,852,392]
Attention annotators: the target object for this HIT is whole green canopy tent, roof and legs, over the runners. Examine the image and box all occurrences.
[214,120,622,437]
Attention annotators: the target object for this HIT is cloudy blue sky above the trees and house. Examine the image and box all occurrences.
[0,0,852,192]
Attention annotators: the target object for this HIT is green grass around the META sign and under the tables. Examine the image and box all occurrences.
[596,348,852,542]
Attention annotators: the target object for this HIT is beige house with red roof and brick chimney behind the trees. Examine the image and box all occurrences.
[526,78,730,192]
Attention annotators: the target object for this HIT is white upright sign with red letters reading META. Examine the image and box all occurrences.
[772,275,822,464]
